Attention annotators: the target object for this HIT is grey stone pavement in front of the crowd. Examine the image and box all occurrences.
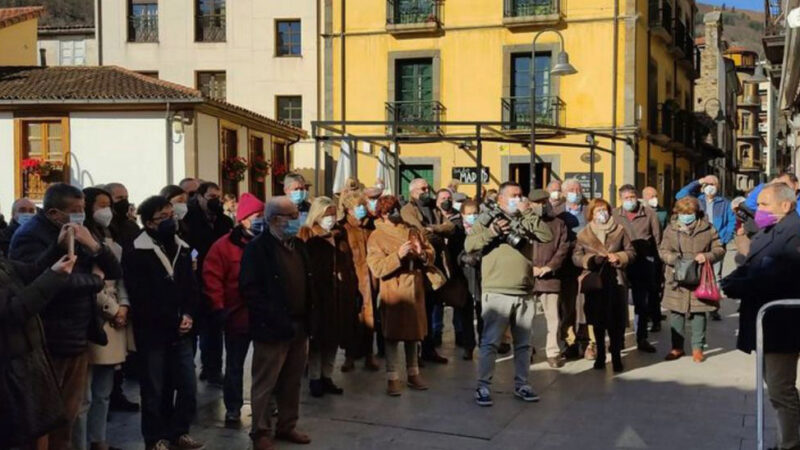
[109,254,775,450]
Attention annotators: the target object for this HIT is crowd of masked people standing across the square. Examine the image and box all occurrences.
[0,173,800,450]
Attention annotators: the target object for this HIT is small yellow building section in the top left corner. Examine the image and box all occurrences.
[0,6,44,66]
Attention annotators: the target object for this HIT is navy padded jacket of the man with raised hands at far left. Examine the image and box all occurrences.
[9,211,117,357]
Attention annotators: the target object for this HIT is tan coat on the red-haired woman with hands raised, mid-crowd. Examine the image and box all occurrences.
[367,220,434,341]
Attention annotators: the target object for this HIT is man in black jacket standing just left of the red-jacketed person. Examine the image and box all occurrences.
[184,182,233,386]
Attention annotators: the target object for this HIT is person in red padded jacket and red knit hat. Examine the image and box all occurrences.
[203,193,264,426]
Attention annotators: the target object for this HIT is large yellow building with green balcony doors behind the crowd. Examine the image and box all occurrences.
[317,0,701,206]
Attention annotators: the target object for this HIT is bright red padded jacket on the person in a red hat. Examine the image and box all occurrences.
[203,226,251,334]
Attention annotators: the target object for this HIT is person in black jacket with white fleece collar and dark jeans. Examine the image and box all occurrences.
[122,196,203,450]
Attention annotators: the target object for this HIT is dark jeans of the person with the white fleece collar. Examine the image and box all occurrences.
[139,337,197,446]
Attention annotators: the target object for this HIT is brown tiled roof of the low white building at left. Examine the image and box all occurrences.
[0,66,306,136]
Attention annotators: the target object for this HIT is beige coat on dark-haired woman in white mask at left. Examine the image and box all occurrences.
[89,238,135,365]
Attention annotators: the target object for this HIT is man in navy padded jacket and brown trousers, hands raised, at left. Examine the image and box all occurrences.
[9,183,122,448]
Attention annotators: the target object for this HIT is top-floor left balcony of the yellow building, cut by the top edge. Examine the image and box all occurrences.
[386,0,442,34]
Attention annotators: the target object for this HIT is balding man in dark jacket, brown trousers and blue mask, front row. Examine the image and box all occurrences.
[239,197,314,450]
